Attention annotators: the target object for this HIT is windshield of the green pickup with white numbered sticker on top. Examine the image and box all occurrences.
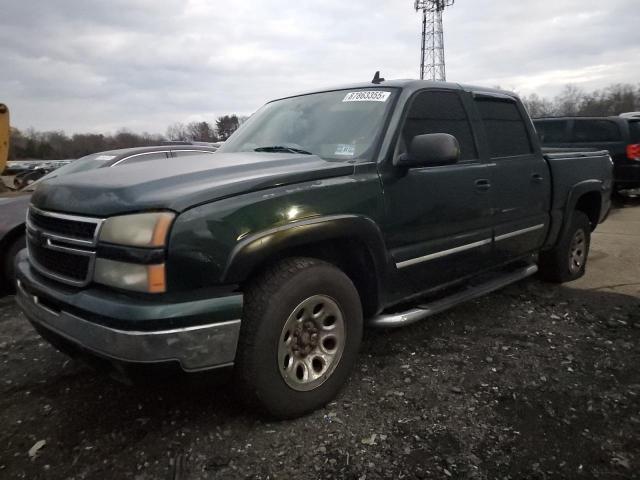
[218,88,394,160]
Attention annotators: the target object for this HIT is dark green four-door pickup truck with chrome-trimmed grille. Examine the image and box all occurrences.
[16,80,612,418]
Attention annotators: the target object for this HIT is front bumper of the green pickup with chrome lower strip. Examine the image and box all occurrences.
[16,255,242,372]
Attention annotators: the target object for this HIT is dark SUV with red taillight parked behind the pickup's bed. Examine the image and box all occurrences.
[533,114,640,191]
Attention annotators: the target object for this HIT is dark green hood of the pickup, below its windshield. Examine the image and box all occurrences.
[32,152,354,217]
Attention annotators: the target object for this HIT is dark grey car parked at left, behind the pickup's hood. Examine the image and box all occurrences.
[0,144,217,289]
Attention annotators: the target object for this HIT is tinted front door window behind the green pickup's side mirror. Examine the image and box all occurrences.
[401,90,478,160]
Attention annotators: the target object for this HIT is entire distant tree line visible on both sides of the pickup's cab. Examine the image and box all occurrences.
[9,84,640,160]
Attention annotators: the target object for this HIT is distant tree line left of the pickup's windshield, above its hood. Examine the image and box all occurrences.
[9,114,246,160]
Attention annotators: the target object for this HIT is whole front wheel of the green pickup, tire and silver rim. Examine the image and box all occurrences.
[236,257,362,418]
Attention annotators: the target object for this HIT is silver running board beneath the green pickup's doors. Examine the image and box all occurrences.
[369,265,538,328]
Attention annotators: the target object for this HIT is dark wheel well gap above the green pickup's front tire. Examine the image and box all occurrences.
[241,238,379,318]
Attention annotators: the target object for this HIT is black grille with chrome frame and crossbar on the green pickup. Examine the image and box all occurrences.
[27,207,102,286]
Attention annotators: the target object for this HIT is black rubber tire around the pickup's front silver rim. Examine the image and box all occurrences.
[235,257,363,419]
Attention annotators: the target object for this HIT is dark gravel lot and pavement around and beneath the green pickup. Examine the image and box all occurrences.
[0,201,640,480]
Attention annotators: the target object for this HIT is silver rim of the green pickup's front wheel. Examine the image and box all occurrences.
[278,295,345,391]
